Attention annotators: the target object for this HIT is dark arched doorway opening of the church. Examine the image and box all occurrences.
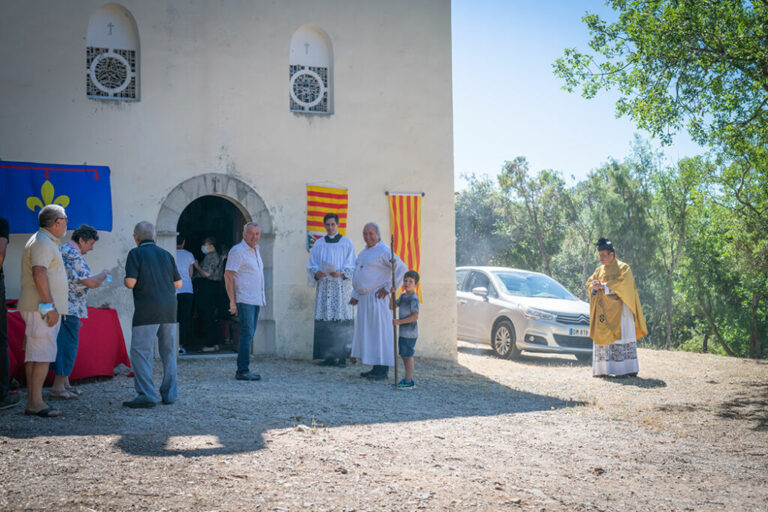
[176,196,246,354]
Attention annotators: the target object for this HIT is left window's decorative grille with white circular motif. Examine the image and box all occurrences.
[85,46,136,100]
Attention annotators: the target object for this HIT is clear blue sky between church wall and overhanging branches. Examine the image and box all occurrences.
[452,0,704,190]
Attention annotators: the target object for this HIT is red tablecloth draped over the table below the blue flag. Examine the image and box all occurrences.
[8,308,131,382]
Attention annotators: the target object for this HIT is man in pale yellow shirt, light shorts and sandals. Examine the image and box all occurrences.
[19,204,69,418]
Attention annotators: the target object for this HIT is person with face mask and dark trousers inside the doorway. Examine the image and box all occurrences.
[194,236,224,352]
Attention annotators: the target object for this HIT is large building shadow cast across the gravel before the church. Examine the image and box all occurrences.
[0,359,586,457]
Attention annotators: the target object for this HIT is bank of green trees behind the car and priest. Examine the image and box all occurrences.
[456,140,768,358]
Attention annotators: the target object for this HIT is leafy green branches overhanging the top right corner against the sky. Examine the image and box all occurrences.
[554,0,768,155]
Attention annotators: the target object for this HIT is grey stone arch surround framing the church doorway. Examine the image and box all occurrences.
[155,173,276,355]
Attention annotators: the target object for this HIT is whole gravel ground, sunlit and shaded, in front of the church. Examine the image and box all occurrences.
[0,342,768,511]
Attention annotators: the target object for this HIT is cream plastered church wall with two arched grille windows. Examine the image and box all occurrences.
[0,0,456,359]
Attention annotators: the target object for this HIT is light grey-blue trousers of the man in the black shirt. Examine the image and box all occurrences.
[131,324,178,403]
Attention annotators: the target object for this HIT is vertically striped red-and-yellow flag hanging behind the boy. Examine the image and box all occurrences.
[389,193,422,301]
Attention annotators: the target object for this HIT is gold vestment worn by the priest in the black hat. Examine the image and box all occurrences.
[587,258,648,345]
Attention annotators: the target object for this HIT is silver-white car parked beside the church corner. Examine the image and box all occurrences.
[456,267,592,361]
